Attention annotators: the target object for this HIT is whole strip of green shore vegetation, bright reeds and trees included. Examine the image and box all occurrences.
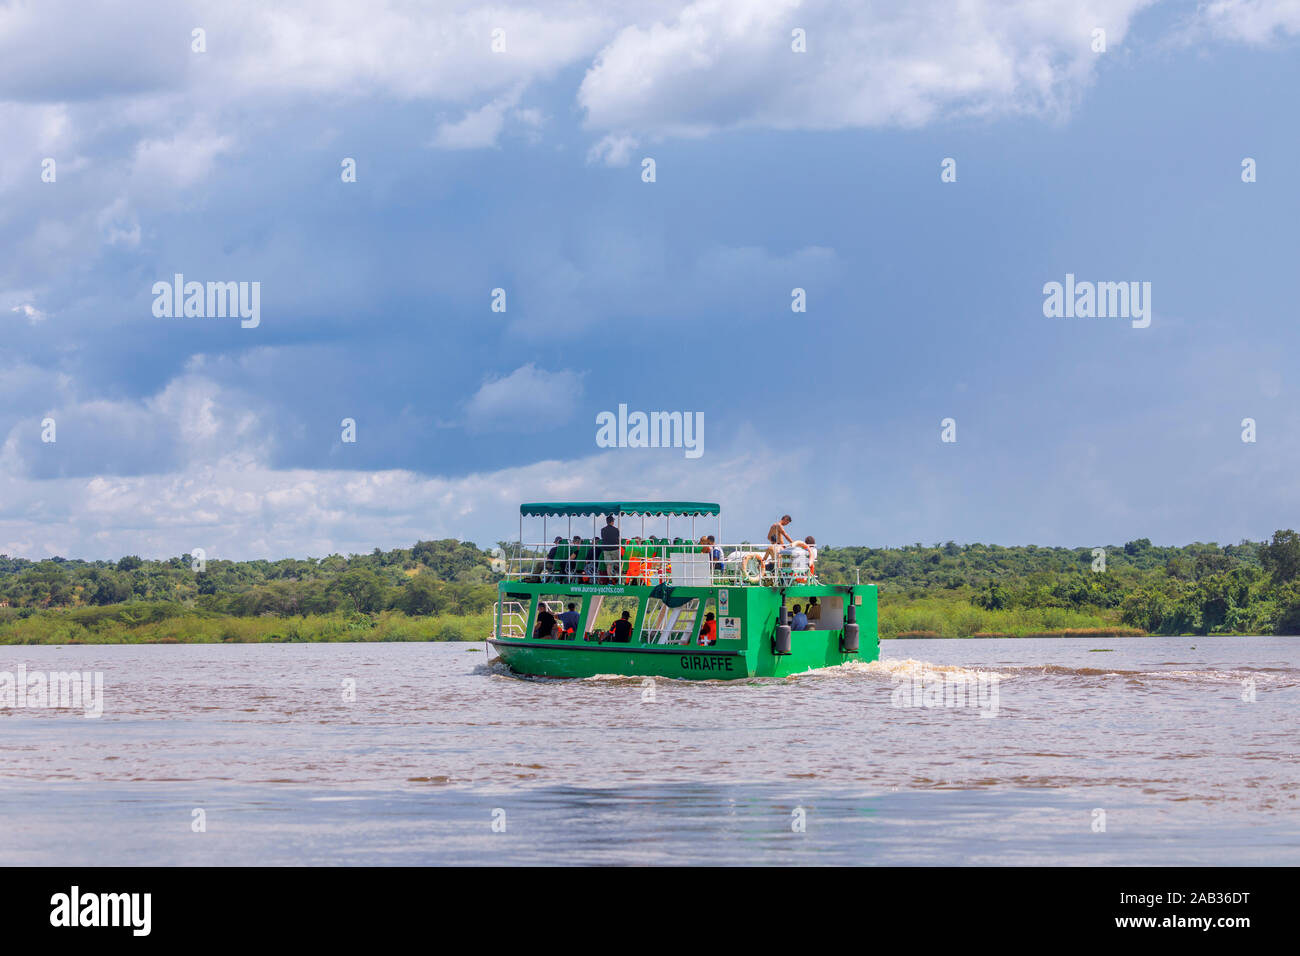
[0,531,1300,644]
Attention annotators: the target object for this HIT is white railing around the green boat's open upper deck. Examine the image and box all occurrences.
[504,538,818,587]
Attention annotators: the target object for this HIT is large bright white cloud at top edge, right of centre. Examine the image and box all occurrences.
[579,0,1153,149]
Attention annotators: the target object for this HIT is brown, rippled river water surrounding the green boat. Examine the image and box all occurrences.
[0,637,1300,865]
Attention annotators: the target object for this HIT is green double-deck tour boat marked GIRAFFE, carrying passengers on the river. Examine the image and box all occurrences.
[488,501,880,680]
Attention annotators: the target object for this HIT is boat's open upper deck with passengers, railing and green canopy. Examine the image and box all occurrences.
[501,501,819,587]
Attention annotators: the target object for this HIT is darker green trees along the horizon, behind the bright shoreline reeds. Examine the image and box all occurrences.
[0,531,1300,633]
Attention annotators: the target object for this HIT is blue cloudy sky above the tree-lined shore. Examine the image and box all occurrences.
[0,0,1300,558]
